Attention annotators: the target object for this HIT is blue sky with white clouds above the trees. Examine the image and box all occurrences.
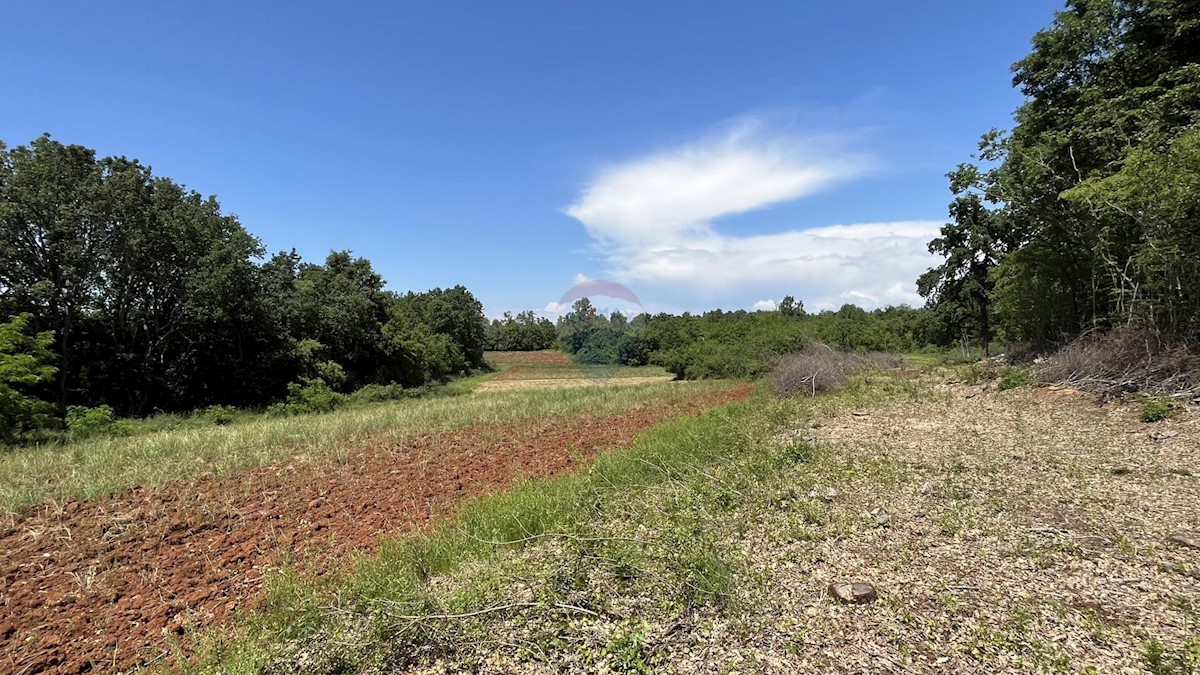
[7,0,1061,316]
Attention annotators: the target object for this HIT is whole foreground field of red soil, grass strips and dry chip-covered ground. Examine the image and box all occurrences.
[0,357,1200,675]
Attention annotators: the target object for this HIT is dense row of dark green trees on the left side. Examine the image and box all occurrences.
[0,136,487,436]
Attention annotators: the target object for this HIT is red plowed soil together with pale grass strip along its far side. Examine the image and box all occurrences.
[0,369,750,673]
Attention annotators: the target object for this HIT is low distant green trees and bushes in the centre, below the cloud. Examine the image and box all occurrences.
[557,297,955,380]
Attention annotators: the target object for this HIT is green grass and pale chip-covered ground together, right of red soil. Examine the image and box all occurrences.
[180,372,1200,674]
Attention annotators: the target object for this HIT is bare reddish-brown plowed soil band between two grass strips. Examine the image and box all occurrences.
[0,384,751,674]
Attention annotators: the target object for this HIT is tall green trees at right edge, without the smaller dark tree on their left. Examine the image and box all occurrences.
[979,0,1200,341]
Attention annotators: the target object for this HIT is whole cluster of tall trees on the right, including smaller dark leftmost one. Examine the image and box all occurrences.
[918,0,1200,352]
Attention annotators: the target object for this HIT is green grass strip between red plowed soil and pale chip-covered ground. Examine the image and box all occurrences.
[175,374,914,673]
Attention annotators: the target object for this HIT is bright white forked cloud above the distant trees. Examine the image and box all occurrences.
[566,118,942,310]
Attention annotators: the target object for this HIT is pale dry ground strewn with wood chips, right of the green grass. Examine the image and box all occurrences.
[396,376,1200,674]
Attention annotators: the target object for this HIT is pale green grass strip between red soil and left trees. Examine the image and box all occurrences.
[0,382,733,514]
